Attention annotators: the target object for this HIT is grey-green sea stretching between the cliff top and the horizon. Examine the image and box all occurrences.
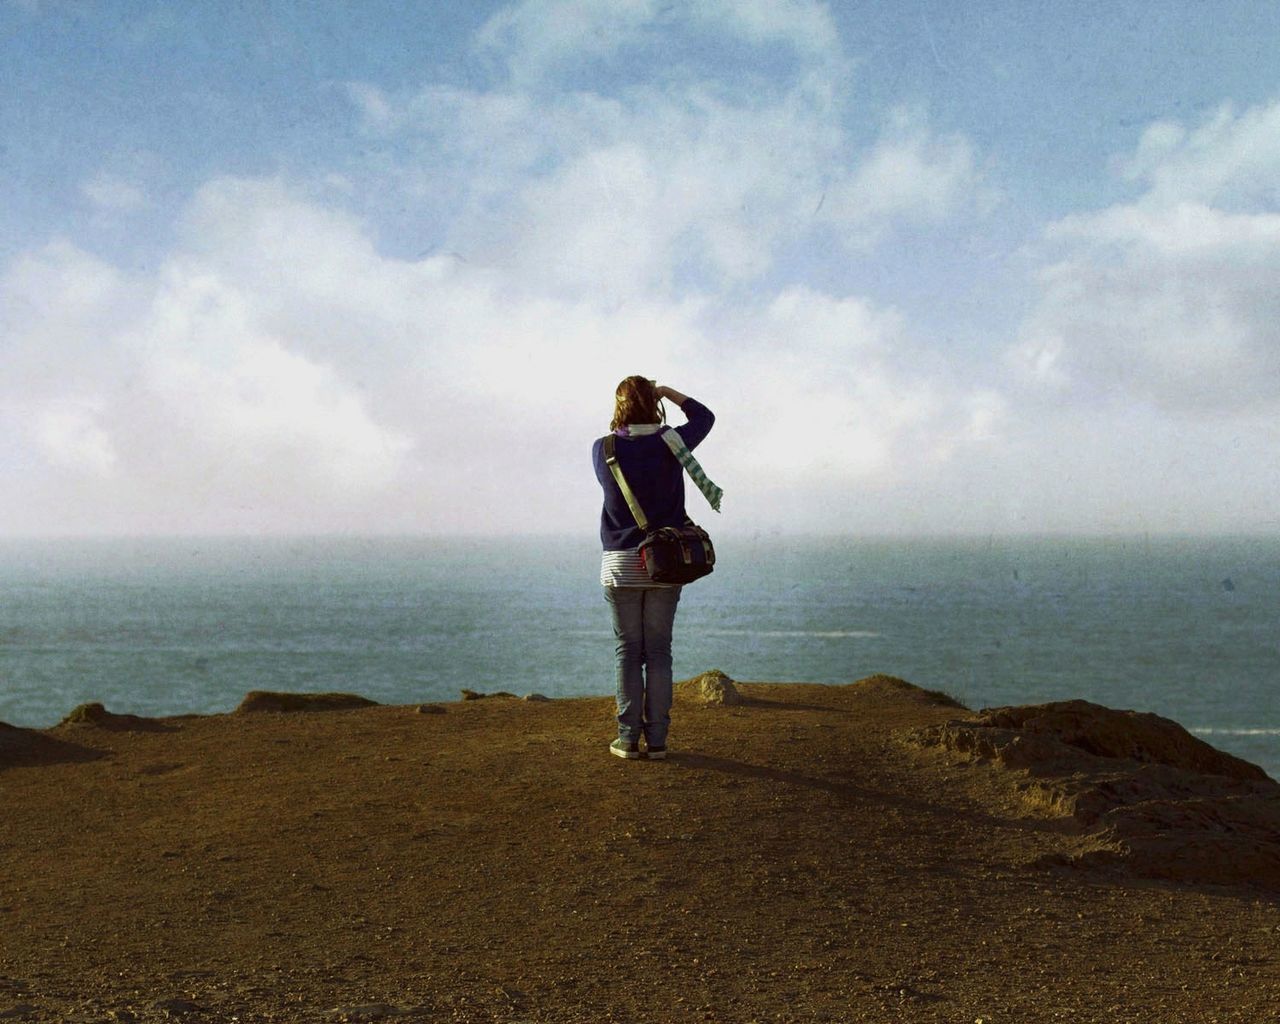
[0,535,1280,778]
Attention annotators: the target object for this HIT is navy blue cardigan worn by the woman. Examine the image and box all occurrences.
[591,398,716,552]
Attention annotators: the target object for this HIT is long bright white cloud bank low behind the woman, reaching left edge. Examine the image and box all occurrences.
[0,171,996,530]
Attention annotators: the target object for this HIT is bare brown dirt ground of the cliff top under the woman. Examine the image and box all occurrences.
[0,681,1280,1024]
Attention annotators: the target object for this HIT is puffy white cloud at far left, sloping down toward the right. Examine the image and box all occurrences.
[0,206,410,527]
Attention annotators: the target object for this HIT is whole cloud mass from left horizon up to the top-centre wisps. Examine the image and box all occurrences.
[0,0,1005,531]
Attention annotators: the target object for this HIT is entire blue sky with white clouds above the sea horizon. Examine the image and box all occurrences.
[0,0,1280,538]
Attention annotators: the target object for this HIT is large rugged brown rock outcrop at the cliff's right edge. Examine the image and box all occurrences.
[910,700,1280,891]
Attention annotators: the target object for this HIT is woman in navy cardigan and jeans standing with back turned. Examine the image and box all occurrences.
[591,376,716,760]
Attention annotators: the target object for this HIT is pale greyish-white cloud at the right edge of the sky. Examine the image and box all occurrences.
[1011,102,1280,416]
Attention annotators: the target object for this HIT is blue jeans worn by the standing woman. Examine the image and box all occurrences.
[604,586,680,746]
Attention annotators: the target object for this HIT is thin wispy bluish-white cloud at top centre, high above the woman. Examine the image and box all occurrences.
[349,1,984,301]
